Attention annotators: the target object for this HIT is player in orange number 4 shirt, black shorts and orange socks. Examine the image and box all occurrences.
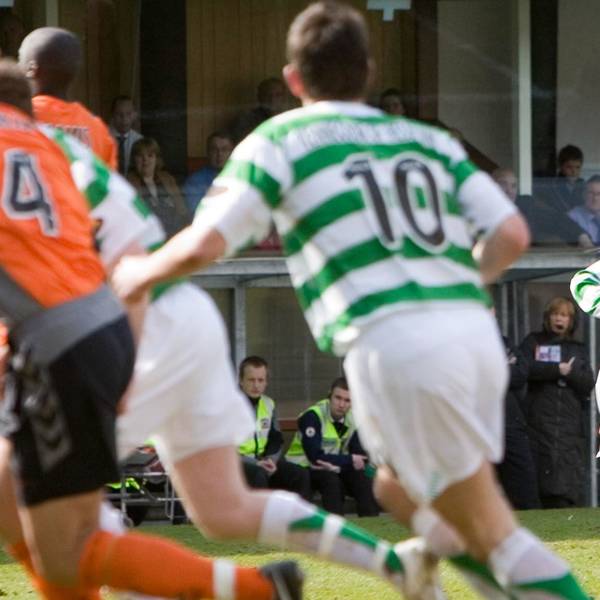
[0,61,300,600]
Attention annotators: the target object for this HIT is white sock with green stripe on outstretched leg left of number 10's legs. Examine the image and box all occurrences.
[258,491,404,584]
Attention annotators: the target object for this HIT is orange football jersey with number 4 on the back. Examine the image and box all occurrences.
[0,104,105,307]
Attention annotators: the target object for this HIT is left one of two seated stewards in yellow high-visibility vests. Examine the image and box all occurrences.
[238,356,312,500]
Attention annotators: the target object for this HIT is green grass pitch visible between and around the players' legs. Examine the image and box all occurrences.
[0,509,600,600]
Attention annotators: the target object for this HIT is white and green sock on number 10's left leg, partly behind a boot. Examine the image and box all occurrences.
[410,507,510,600]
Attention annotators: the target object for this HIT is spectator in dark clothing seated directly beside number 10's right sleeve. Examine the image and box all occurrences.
[492,168,593,248]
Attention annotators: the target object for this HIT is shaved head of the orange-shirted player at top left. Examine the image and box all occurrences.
[19,27,82,95]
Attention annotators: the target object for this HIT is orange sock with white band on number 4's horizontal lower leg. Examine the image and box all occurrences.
[79,531,273,600]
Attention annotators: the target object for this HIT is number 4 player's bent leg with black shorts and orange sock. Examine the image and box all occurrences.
[13,318,288,600]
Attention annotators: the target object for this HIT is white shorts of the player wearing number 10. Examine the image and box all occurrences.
[344,306,508,504]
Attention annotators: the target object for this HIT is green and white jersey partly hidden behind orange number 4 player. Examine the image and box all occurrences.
[39,125,166,265]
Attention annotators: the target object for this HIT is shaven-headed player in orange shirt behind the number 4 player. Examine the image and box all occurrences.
[19,27,117,169]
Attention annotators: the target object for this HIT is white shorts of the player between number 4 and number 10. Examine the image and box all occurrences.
[117,283,254,466]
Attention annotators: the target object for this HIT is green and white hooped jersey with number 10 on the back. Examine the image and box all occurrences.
[194,102,516,355]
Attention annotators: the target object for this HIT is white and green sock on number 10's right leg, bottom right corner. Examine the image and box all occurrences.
[488,528,589,600]
